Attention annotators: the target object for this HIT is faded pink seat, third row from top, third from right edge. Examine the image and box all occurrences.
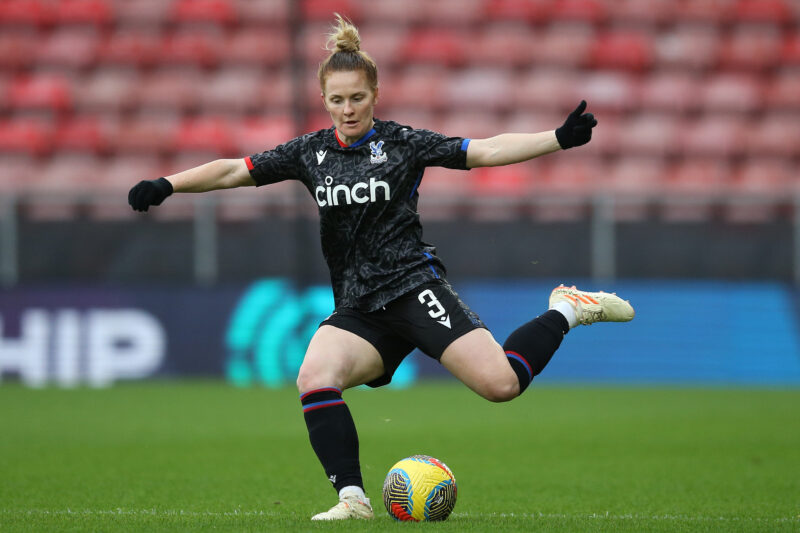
[639,70,701,113]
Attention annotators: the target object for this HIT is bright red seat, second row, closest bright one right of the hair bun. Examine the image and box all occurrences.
[401,28,470,67]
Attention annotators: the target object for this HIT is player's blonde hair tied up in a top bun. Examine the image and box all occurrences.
[317,13,378,92]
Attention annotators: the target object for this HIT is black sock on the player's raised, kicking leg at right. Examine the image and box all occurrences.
[503,309,569,394]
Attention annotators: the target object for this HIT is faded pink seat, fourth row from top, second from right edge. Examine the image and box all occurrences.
[680,115,746,157]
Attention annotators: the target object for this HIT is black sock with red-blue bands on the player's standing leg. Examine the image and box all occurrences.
[300,387,364,492]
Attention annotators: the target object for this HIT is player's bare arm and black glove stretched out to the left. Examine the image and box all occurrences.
[128,159,256,211]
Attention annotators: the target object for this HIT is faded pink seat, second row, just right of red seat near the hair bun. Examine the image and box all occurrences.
[468,22,535,67]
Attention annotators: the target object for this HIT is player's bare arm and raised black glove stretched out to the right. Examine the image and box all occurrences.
[467,100,597,168]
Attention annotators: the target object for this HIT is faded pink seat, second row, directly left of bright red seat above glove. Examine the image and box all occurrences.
[530,22,596,68]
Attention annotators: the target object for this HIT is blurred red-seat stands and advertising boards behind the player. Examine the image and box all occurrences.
[0,0,800,386]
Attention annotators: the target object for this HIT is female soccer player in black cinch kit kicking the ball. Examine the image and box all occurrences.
[128,15,634,520]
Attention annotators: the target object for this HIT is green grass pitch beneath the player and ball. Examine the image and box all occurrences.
[0,382,800,532]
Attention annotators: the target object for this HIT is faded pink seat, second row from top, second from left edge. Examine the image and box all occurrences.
[36,26,100,69]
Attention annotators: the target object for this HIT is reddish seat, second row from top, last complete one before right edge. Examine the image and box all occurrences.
[721,25,782,71]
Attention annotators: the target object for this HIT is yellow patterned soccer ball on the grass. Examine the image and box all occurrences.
[383,455,457,522]
